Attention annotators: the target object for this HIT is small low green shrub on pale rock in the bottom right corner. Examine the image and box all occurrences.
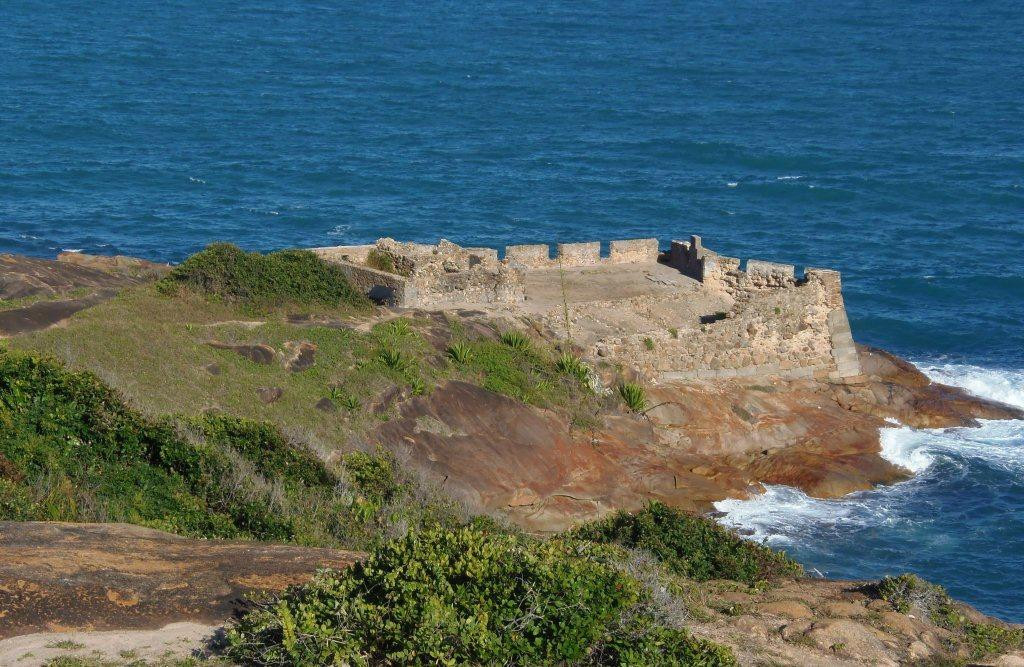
[874,574,1024,660]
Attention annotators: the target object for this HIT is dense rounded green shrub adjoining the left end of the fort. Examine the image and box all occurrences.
[160,243,370,309]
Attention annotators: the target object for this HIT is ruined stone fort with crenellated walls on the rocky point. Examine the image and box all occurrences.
[313,236,860,381]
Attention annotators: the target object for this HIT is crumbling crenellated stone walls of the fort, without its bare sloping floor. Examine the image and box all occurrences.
[314,236,860,380]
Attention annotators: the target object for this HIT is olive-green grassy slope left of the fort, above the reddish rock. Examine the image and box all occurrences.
[5,286,597,449]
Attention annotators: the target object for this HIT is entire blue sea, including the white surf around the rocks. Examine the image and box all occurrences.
[0,0,1024,621]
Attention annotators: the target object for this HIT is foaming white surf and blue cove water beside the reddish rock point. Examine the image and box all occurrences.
[715,364,1024,620]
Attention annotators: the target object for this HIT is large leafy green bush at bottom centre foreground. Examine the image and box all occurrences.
[227,528,735,665]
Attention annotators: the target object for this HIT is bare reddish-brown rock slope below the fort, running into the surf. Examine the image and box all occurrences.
[375,348,1024,532]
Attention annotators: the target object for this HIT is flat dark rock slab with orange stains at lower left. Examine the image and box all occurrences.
[0,522,362,639]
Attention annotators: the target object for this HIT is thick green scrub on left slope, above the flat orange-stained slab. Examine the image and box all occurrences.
[0,352,459,547]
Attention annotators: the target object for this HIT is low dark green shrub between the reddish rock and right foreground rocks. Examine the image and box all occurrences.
[574,502,803,584]
